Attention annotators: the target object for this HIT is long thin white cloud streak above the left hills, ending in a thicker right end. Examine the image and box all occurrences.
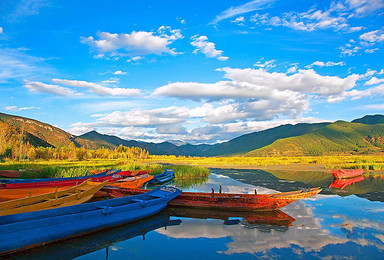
[52,79,140,96]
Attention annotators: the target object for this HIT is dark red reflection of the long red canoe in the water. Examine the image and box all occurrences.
[163,206,296,227]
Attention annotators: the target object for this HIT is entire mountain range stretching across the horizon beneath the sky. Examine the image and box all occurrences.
[0,113,384,156]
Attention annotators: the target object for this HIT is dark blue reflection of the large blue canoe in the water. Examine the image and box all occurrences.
[7,213,181,259]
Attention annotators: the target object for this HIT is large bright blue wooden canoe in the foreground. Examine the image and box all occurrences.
[0,186,181,255]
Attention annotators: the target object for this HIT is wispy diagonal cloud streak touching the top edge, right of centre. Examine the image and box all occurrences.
[211,0,274,24]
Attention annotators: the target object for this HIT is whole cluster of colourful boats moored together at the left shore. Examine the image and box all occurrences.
[0,170,321,254]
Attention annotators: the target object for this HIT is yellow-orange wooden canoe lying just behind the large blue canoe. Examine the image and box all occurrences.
[0,181,108,216]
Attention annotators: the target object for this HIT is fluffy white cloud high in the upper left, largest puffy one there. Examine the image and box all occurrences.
[81,26,183,58]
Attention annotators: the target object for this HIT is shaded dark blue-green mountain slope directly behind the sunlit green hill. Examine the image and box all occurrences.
[203,123,330,156]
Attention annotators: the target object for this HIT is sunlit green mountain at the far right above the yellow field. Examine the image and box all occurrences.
[246,121,384,156]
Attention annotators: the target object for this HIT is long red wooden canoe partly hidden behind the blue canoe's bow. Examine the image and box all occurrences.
[104,188,321,211]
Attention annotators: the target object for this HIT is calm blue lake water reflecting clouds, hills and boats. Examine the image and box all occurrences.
[6,169,384,260]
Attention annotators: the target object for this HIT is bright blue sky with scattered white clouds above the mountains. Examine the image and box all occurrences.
[0,0,384,144]
